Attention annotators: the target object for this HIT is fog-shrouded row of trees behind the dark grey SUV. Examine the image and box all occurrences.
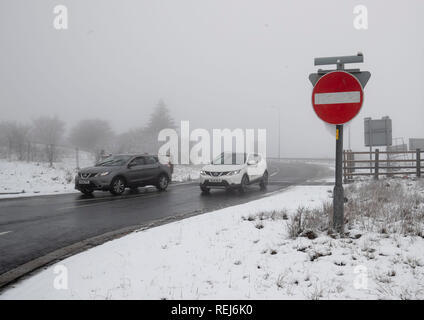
[0,100,175,163]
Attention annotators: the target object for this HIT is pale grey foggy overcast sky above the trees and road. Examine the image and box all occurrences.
[0,0,424,157]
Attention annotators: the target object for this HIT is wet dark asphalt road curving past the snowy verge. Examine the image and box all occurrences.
[0,161,330,275]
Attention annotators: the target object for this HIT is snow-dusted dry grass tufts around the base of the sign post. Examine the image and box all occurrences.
[268,179,424,240]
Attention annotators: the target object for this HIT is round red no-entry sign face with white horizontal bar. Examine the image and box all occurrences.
[312,71,364,124]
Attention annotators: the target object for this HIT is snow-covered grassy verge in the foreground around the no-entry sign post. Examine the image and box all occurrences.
[0,179,424,299]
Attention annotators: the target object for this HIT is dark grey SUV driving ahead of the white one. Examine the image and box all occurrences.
[75,154,171,195]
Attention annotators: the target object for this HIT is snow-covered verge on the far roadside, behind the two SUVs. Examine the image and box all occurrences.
[0,156,200,199]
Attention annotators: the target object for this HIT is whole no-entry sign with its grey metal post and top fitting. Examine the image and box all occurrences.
[309,53,371,233]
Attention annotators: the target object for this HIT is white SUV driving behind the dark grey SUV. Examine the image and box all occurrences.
[200,152,268,193]
